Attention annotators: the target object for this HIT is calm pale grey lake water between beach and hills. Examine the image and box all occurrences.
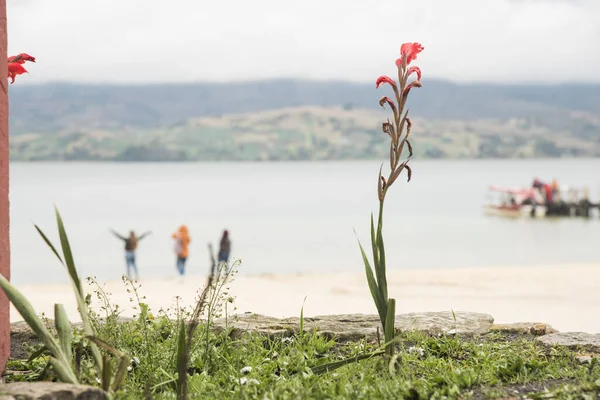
[10,159,600,283]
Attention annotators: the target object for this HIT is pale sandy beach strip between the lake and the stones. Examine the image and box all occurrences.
[11,265,600,333]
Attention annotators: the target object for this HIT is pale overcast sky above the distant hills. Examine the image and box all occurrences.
[7,0,600,83]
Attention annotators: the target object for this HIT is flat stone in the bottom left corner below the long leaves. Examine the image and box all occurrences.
[0,382,108,400]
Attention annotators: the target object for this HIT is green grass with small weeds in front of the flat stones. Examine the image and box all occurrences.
[6,303,600,399]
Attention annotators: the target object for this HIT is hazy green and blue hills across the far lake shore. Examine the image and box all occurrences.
[9,79,600,161]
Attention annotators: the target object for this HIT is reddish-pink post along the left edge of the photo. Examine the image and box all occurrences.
[0,0,10,374]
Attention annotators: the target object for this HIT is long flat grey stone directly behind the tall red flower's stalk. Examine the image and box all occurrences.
[214,311,494,342]
